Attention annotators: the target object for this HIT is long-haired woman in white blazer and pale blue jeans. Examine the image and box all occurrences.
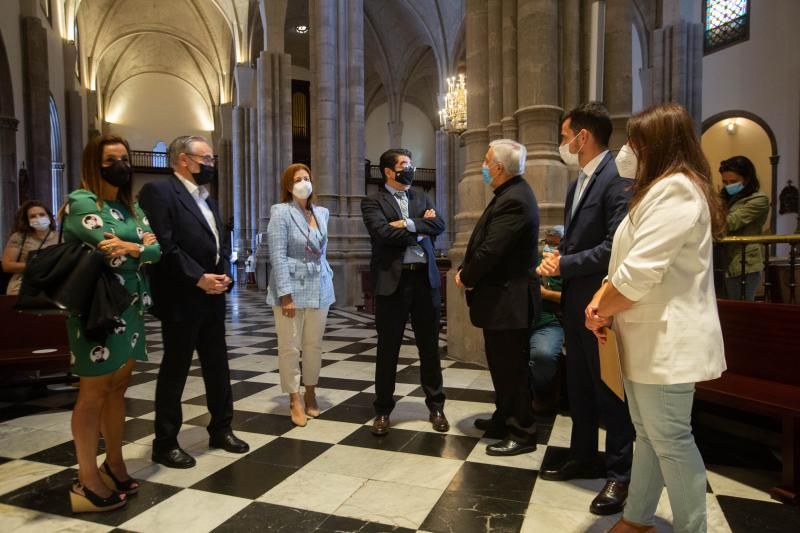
[586,103,725,533]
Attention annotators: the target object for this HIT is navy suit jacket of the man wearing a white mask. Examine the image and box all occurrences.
[558,152,633,316]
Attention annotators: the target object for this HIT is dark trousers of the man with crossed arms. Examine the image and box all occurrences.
[373,268,445,415]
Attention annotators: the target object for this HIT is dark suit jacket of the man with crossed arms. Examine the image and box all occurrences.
[361,185,444,296]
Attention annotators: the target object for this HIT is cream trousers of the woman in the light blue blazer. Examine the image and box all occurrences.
[272,306,328,393]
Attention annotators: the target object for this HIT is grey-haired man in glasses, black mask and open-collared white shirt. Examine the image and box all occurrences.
[139,137,249,468]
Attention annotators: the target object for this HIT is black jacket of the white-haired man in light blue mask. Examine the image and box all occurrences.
[461,176,541,329]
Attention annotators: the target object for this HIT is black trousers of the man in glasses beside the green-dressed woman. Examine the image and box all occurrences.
[153,309,233,451]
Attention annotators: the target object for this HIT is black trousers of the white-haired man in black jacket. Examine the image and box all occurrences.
[483,329,536,442]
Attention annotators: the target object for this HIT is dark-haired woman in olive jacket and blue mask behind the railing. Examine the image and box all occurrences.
[719,155,769,302]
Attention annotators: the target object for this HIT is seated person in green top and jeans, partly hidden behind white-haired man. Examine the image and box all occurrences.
[529,222,564,414]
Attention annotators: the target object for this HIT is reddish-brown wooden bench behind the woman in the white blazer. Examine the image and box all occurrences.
[696,300,800,504]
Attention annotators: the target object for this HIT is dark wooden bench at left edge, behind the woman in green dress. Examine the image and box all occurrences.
[0,295,75,385]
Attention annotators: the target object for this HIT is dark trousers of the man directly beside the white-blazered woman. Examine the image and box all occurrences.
[564,302,636,481]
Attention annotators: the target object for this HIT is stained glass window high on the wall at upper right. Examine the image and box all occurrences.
[703,0,750,54]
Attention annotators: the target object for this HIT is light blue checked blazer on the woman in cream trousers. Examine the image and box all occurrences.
[267,202,336,308]
